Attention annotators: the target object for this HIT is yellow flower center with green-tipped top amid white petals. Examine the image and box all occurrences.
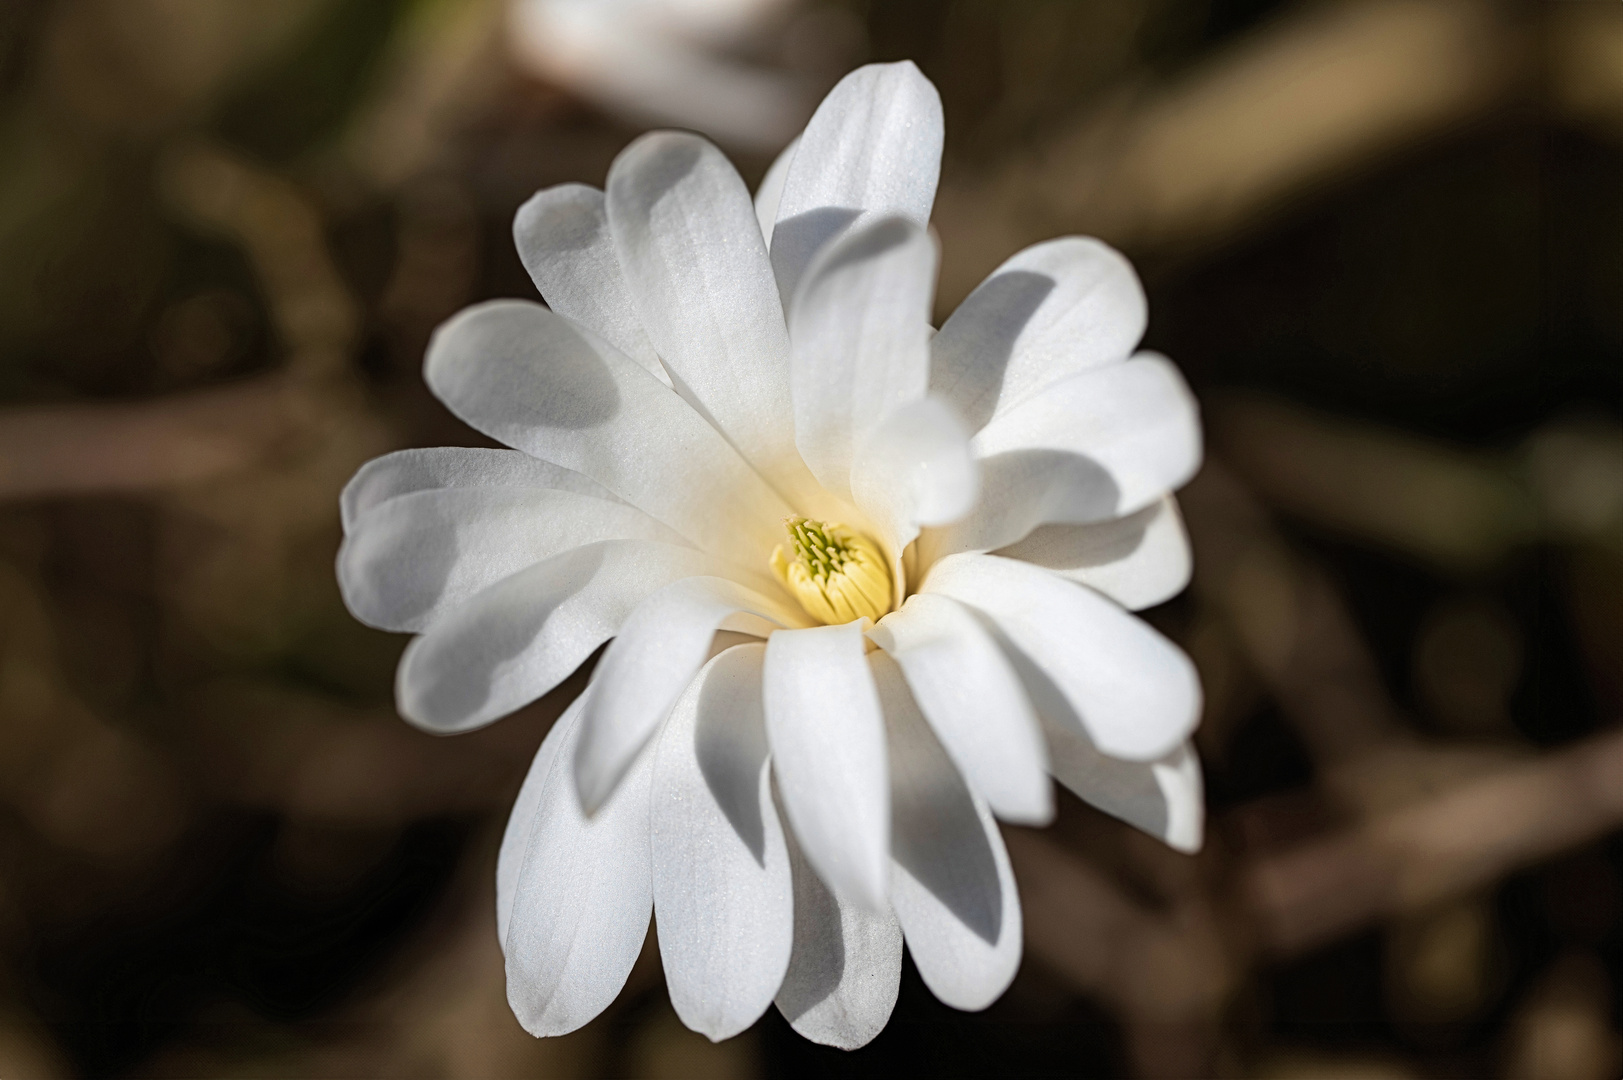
[773,516,891,625]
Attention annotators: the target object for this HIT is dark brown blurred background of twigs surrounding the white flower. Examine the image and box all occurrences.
[0,0,1623,1080]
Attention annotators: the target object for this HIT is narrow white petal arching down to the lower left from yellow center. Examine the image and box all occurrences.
[575,578,807,812]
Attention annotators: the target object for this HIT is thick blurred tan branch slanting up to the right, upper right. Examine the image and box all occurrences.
[935,0,1522,309]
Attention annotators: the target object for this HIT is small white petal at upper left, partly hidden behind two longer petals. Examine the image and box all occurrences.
[513,184,670,387]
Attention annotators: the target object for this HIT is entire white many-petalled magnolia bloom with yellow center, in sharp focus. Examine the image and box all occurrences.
[339,63,1201,1048]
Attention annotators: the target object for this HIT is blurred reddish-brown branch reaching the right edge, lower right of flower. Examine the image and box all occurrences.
[1240,732,1623,953]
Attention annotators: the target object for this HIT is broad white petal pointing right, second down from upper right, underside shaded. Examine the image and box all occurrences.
[928,352,1201,557]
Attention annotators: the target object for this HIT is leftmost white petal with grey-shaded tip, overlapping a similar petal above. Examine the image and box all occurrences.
[338,487,683,630]
